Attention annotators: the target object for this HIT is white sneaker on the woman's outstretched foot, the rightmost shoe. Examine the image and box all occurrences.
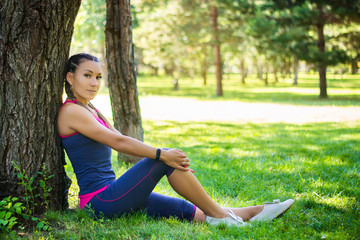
[249,199,294,222]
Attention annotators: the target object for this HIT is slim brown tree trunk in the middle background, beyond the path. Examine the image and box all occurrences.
[211,6,223,97]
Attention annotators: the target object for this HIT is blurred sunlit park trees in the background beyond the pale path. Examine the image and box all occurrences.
[71,0,360,101]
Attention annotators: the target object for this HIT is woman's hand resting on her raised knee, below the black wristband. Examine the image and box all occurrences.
[160,148,190,171]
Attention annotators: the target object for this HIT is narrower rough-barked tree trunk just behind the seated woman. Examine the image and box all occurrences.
[105,0,143,162]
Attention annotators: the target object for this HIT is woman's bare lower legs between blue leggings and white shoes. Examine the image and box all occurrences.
[168,169,264,222]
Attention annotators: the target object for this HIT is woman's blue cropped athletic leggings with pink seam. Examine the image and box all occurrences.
[87,158,196,221]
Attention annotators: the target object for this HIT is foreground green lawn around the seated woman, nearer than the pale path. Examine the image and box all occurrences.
[58,101,360,239]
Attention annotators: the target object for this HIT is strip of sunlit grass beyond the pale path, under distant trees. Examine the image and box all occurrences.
[133,74,360,106]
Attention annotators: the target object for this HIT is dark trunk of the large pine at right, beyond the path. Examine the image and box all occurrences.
[316,4,328,98]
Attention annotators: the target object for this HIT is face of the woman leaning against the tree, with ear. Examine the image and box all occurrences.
[66,60,101,104]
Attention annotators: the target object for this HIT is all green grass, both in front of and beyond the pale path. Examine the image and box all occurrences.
[0,72,360,239]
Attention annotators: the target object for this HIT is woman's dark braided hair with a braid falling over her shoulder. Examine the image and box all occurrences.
[64,53,106,122]
